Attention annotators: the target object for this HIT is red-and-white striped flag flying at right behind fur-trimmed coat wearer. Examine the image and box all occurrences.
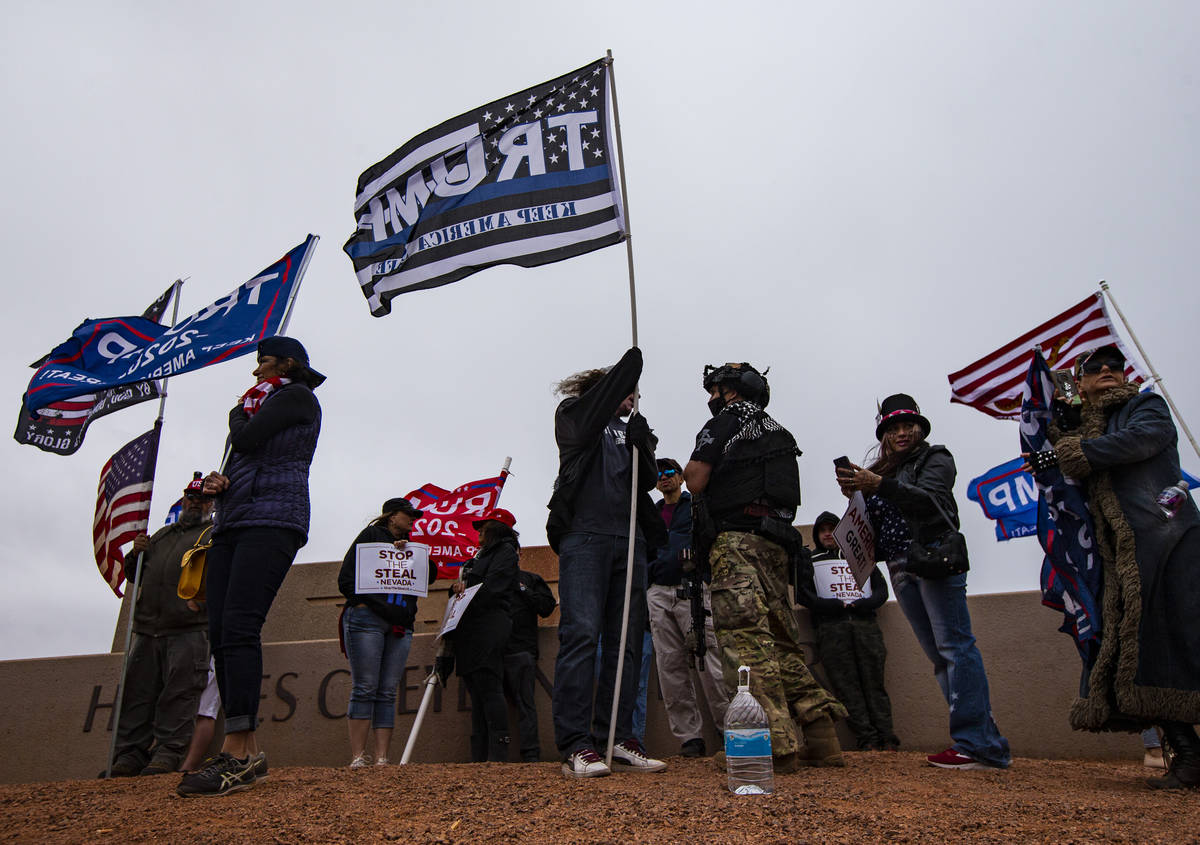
[947,292,1146,419]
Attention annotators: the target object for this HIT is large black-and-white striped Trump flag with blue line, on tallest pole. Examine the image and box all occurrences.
[343,59,625,317]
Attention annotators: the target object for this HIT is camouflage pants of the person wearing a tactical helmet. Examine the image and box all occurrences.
[708,531,846,756]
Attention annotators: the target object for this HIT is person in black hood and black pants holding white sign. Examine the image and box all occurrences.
[796,510,900,751]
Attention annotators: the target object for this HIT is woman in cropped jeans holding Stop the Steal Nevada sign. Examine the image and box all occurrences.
[337,497,438,768]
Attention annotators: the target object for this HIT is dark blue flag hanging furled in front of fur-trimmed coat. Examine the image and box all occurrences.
[1021,350,1102,669]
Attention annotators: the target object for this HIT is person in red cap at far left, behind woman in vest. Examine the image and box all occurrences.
[101,473,212,777]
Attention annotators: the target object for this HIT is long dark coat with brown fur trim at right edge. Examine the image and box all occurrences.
[1051,384,1200,731]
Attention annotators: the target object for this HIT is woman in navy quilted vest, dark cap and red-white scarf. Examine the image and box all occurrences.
[175,336,325,796]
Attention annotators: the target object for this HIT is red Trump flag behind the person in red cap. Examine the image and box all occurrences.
[406,472,509,579]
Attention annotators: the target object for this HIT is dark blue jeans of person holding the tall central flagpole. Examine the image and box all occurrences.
[552,532,646,756]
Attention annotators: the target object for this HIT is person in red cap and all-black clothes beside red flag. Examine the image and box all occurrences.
[446,508,521,763]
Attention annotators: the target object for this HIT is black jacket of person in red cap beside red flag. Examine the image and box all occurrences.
[448,538,518,675]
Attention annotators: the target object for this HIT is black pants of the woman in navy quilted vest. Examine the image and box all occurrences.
[205,528,304,733]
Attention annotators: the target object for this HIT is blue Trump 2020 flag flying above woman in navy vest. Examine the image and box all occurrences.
[24,235,317,409]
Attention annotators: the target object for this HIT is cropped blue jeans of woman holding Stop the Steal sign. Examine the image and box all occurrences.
[342,605,413,729]
